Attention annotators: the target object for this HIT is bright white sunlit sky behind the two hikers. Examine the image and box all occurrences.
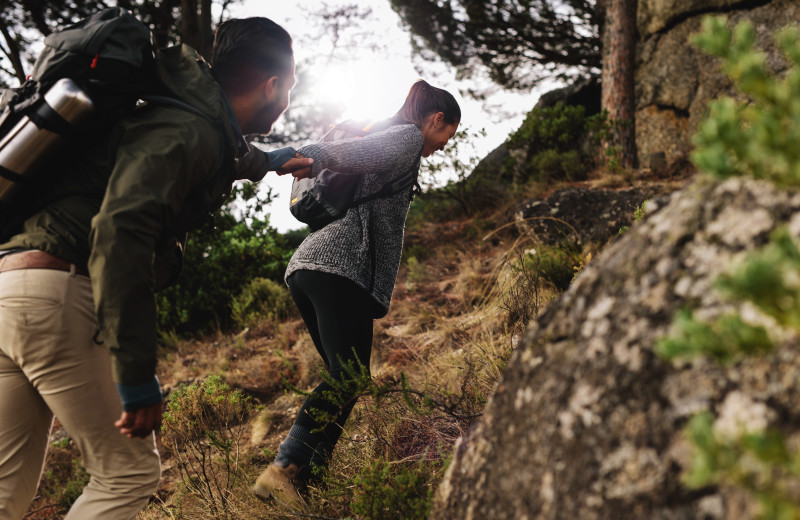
[219,0,539,232]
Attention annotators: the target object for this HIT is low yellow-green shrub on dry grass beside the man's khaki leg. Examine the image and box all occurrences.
[161,376,255,518]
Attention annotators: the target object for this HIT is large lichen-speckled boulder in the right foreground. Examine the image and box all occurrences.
[431,179,800,520]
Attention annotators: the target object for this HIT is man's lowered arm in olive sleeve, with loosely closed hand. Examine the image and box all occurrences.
[89,109,221,436]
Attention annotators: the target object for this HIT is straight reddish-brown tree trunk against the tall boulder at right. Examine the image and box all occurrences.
[602,0,637,168]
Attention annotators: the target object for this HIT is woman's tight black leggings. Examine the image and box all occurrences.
[287,270,377,463]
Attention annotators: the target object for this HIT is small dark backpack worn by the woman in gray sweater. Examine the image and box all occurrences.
[289,119,422,231]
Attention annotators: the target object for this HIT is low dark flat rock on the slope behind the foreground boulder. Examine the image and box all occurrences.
[509,185,666,244]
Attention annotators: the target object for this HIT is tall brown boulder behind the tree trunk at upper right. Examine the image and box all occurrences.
[636,0,800,164]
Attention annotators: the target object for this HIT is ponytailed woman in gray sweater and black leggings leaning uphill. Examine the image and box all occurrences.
[253,80,461,510]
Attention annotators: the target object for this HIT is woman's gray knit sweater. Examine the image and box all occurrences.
[286,124,423,317]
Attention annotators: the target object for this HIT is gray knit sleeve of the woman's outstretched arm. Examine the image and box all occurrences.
[298,125,424,176]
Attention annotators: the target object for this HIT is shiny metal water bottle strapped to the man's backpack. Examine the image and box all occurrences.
[0,78,94,203]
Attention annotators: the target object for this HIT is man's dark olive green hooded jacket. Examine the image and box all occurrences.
[0,46,267,409]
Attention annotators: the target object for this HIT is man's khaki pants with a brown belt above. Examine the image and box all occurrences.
[0,269,161,520]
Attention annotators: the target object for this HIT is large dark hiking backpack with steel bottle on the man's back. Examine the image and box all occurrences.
[0,7,222,237]
